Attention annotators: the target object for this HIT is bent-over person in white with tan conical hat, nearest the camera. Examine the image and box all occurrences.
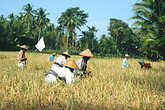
[45,60,78,85]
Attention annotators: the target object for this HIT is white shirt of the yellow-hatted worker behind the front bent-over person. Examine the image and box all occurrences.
[51,56,66,69]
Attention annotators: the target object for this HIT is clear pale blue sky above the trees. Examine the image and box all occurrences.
[0,0,138,38]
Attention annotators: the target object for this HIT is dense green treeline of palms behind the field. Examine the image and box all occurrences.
[0,0,165,61]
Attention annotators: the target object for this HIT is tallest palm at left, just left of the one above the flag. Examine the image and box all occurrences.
[22,3,35,28]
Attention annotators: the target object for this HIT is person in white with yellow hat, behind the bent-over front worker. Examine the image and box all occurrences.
[51,51,71,69]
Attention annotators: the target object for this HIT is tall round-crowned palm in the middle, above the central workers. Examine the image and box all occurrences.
[58,7,88,49]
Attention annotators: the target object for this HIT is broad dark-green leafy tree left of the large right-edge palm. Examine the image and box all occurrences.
[108,19,139,54]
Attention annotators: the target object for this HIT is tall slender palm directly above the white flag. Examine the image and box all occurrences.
[36,8,50,41]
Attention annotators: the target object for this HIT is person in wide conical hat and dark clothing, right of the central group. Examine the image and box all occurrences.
[74,49,93,75]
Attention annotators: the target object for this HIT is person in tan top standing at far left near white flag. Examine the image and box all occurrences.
[17,45,27,67]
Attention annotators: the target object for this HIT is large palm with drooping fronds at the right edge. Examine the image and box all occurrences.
[130,0,165,56]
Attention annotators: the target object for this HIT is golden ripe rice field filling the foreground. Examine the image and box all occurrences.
[0,51,165,110]
